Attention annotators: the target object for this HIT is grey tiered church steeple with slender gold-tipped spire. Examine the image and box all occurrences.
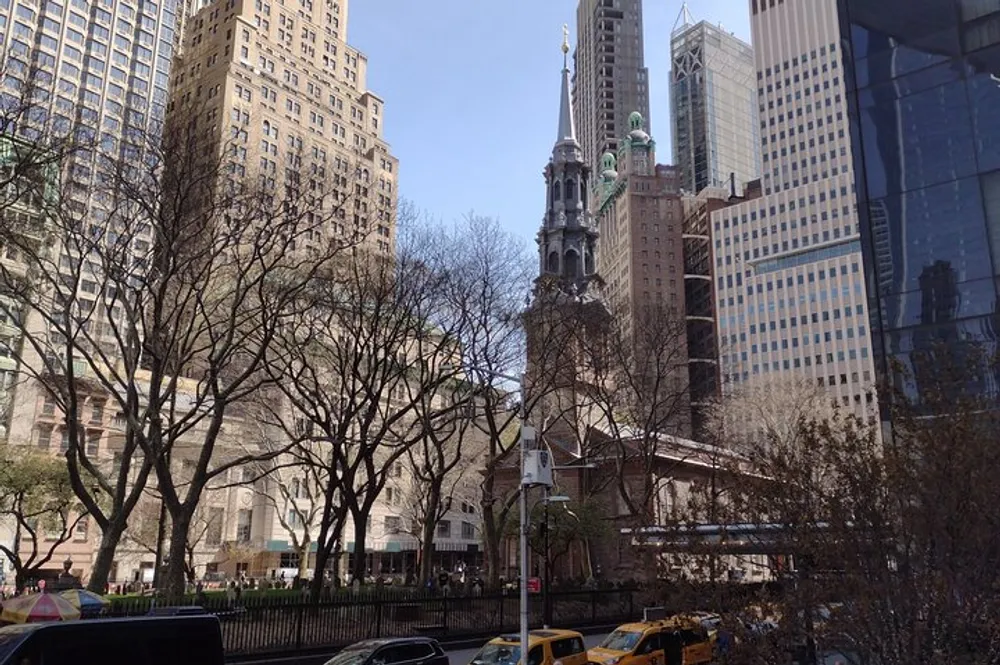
[537,26,598,295]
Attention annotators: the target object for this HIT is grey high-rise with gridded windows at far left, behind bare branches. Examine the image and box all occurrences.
[0,0,177,440]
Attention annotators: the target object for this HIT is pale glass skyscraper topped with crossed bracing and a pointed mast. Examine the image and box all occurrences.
[670,3,760,194]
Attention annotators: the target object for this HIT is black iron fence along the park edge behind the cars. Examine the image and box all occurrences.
[109,589,641,660]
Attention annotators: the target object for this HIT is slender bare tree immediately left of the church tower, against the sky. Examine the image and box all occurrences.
[430,213,571,587]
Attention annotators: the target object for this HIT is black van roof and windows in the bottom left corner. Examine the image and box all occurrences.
[0,615,225,665]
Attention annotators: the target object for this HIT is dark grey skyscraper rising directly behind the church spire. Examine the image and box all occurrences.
[573,0,649,178]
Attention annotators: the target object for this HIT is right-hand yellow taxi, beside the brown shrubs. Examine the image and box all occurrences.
[587,608,715,665]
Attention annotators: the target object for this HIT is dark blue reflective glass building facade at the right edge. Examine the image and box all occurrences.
[840,0,1000,396]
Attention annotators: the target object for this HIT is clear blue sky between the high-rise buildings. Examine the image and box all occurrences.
[348,0,750,246]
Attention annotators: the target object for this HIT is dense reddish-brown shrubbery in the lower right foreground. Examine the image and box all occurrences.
[700,349,1000,665]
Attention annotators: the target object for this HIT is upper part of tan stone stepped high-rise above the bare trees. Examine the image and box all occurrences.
[171,0,397,255]
